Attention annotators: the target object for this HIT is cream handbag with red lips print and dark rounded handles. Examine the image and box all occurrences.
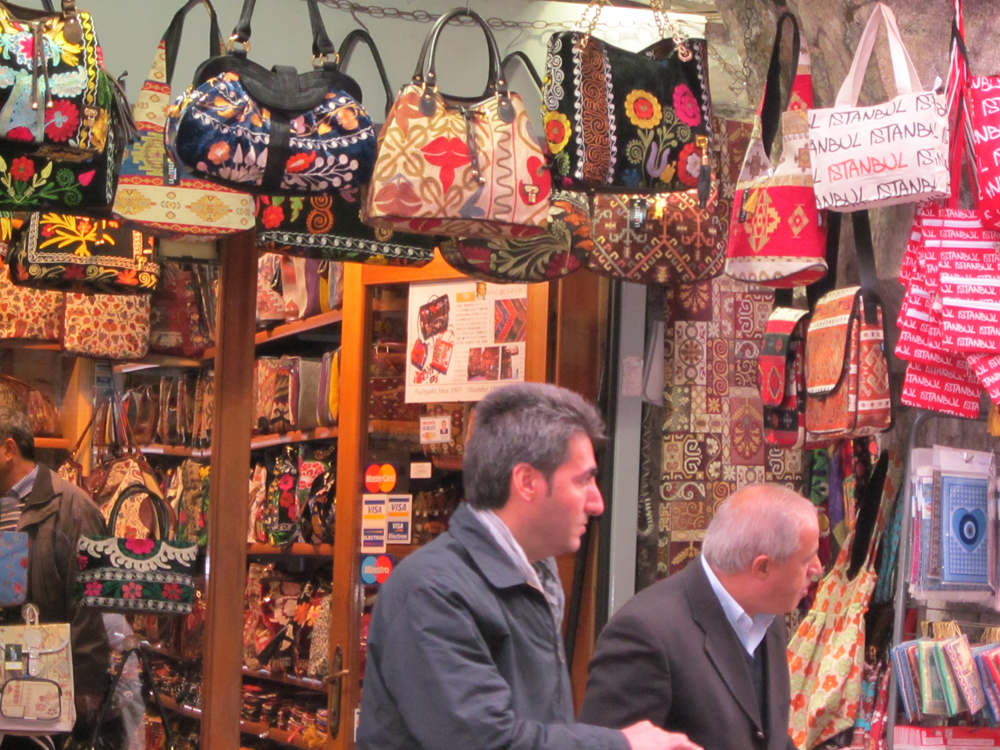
[362,8,552,237]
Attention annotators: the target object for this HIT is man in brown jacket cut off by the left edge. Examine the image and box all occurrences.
[0,407,111,750]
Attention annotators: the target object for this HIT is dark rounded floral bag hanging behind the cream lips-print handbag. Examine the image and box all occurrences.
[441,190,594,284]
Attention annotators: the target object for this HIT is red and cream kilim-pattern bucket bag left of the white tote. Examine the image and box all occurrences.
[726,13,827,287]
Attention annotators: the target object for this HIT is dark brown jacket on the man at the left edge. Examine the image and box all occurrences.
[17,464,111,696]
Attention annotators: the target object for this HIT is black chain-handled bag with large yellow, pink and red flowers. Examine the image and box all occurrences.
[542,0,711,197]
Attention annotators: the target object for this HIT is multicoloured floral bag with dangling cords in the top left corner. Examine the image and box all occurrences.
[0,5,106,156]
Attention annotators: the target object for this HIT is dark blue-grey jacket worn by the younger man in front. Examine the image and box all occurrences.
[358,505,629,750]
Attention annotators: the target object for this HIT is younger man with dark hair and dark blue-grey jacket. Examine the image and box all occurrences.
[358,384,700,750]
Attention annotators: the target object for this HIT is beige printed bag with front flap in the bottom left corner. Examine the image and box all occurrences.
[0,604,76,735]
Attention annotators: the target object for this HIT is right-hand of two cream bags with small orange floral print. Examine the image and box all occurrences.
[61,292,150,360]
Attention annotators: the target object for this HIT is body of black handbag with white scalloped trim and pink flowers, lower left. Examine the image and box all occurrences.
[76,536,198,615]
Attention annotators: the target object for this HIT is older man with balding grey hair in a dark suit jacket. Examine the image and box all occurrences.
[580,484,823,750]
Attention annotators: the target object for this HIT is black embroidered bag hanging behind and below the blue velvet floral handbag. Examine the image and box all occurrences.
[257,29,434,266]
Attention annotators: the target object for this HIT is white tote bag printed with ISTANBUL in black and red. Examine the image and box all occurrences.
[809,3,950,211]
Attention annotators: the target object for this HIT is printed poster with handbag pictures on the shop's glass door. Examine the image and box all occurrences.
[406,281,528,404]
